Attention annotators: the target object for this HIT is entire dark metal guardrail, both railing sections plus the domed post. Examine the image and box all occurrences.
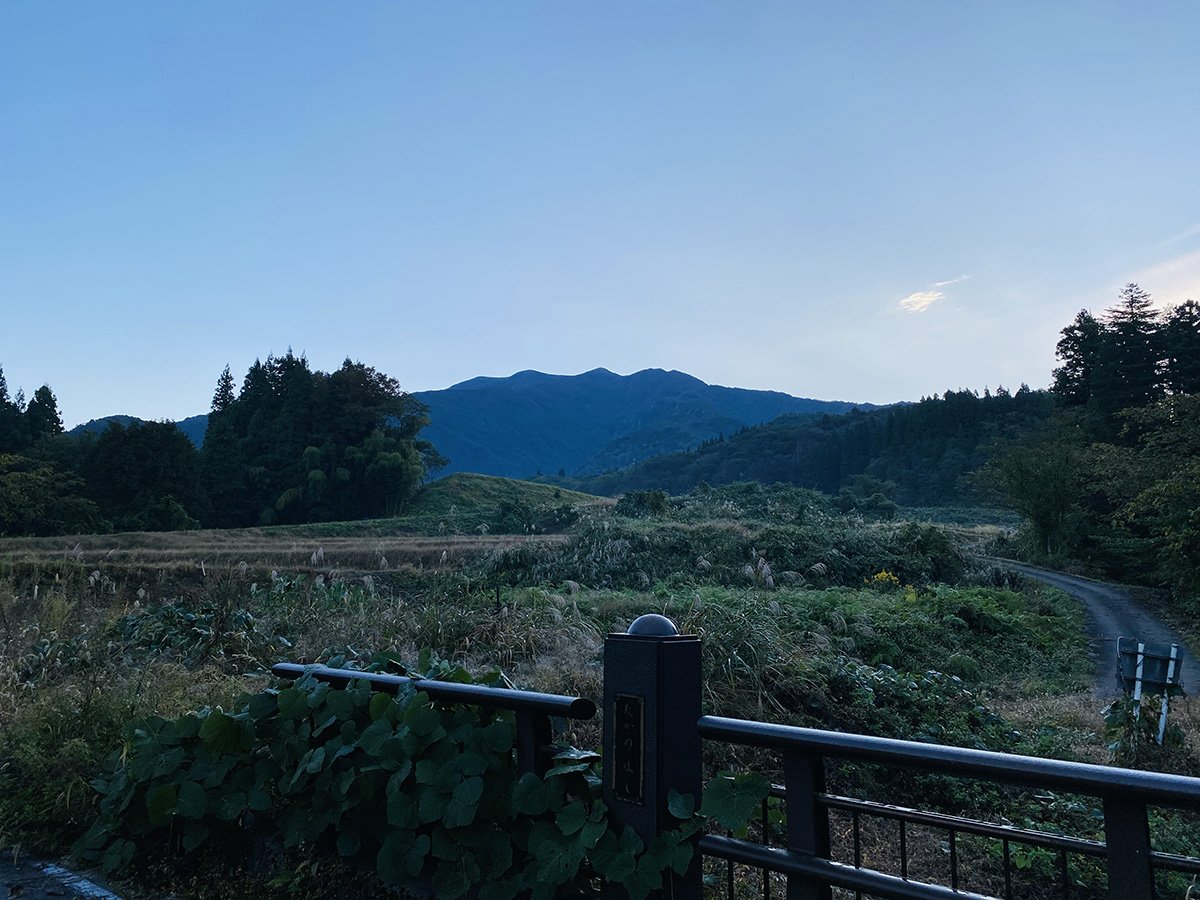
[272,616,1200,900]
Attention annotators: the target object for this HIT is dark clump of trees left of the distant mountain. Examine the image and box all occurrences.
[0,350,445,535]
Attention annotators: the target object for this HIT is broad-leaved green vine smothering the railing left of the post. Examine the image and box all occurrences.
[76,654,769,900]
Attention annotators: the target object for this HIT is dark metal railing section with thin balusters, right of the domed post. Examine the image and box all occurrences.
[697,716,1200,900]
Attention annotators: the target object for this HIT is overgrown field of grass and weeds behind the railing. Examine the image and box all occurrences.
[0,479,1195,887]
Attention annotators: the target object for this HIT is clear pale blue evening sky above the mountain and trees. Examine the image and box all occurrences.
[0,0,1200,427]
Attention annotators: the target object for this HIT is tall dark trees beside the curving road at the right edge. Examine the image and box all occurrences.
[988,284,1200,602]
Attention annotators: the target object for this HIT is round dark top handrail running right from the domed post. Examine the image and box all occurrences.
[697,715,1200,810]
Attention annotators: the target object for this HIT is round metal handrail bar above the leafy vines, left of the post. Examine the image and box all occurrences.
[271,662,596,719]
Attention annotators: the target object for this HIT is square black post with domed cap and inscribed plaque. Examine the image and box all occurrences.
[604,614,703,900]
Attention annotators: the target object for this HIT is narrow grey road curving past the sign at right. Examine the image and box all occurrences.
[996,559,1200,700]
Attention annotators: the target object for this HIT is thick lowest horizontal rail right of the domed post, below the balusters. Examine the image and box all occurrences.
[700,834,995,900]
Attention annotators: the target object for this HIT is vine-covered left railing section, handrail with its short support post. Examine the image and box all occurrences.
[271,662,596,775]
